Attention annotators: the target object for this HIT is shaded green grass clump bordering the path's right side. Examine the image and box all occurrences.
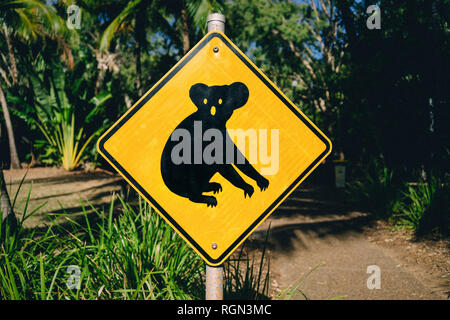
[347,166,450,237]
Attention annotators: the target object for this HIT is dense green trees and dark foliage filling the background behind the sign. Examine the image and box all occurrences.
[0,0,450,231]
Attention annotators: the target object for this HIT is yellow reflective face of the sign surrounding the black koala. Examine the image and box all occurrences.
[99,32,331,265]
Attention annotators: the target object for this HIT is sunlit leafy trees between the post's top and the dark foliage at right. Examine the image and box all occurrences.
[226,0,345,135]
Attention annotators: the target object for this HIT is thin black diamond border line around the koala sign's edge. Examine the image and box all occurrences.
[98,32,331,264]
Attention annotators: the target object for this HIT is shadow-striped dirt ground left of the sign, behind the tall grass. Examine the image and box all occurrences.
[4,167,123,227]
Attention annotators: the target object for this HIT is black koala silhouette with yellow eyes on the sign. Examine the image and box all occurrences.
[161,82,269,207]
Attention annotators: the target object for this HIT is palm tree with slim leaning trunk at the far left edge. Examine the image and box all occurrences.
[0,0,69,169]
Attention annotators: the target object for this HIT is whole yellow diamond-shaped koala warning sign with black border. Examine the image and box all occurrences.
[98,31,331,266]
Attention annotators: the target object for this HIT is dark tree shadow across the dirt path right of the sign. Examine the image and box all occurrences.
[250,186,374,253]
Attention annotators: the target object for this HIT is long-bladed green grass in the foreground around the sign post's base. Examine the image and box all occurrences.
[0,180,269,300]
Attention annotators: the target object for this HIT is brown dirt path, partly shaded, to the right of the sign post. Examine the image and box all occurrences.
[252,188,450,299]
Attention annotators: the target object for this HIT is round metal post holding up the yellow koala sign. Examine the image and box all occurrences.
[205,13,225,300]
